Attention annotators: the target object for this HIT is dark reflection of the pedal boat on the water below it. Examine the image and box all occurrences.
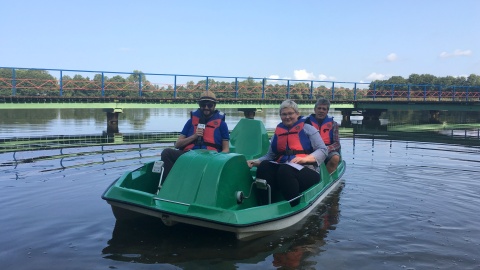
[102,186,341,269]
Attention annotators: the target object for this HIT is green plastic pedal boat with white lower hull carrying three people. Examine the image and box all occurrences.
[102,119,346,240]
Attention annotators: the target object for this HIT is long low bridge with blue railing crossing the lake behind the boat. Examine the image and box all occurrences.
[0,67,480,129]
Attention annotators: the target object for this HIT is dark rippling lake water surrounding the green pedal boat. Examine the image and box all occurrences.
[0,108,480,269]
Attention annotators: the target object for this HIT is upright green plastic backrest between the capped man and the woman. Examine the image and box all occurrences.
[230,118,270,160]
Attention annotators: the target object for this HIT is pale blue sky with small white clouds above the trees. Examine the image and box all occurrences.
[0,0,480,82]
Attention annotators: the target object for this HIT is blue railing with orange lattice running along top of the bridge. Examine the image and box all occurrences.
[0,67,480,101]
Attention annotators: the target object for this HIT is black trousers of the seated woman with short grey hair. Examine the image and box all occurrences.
[257,160,320,206]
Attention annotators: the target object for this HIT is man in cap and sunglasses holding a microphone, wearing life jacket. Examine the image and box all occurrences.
[161,91,230,180]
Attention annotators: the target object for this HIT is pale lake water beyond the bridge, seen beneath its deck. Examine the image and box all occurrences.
[0,109,334,138]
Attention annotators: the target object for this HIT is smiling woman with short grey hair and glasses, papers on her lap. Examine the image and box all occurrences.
[247,99,327,206]
